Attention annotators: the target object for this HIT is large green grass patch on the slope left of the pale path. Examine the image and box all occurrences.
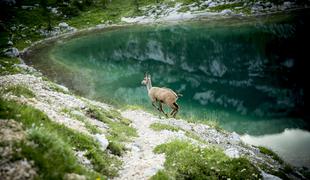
[0,99,121,179]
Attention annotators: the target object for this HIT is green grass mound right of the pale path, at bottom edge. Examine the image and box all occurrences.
[152,140,261,180]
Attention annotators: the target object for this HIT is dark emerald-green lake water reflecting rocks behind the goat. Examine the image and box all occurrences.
[26,11,310,167]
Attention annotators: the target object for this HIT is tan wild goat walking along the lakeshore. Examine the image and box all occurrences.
[141,73,179,118]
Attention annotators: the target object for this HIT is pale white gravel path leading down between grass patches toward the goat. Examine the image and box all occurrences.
[116,110,187,180]
